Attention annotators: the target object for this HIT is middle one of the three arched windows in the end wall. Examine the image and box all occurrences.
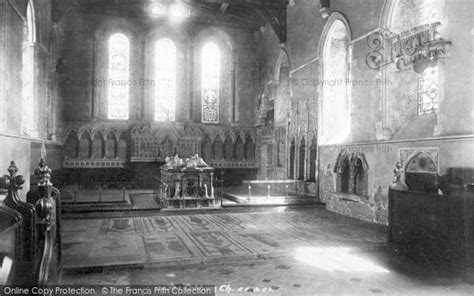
[155,38,176,121]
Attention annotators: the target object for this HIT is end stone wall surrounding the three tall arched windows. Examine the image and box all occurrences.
[60,11,259,126]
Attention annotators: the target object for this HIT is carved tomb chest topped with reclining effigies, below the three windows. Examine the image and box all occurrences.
[160,154,218,209]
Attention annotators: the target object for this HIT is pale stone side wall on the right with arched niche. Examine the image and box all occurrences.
[259,0,474,224]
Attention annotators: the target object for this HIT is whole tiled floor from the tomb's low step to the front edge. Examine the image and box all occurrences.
[62,207,474,295]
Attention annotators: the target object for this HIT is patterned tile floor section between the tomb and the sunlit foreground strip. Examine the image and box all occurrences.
[63,207,386,269]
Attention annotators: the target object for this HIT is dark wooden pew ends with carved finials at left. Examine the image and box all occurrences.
[0,159,61,285]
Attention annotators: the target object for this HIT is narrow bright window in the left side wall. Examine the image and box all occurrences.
[22,1,36,135]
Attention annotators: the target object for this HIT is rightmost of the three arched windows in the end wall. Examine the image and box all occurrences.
[201,42,221,123]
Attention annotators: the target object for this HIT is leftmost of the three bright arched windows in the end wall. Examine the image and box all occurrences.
[108,33,130,120]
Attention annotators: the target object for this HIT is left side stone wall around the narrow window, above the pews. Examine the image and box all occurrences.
[0,0,64,197]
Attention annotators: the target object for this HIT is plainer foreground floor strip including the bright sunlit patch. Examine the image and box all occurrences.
[63,251,474,296]
